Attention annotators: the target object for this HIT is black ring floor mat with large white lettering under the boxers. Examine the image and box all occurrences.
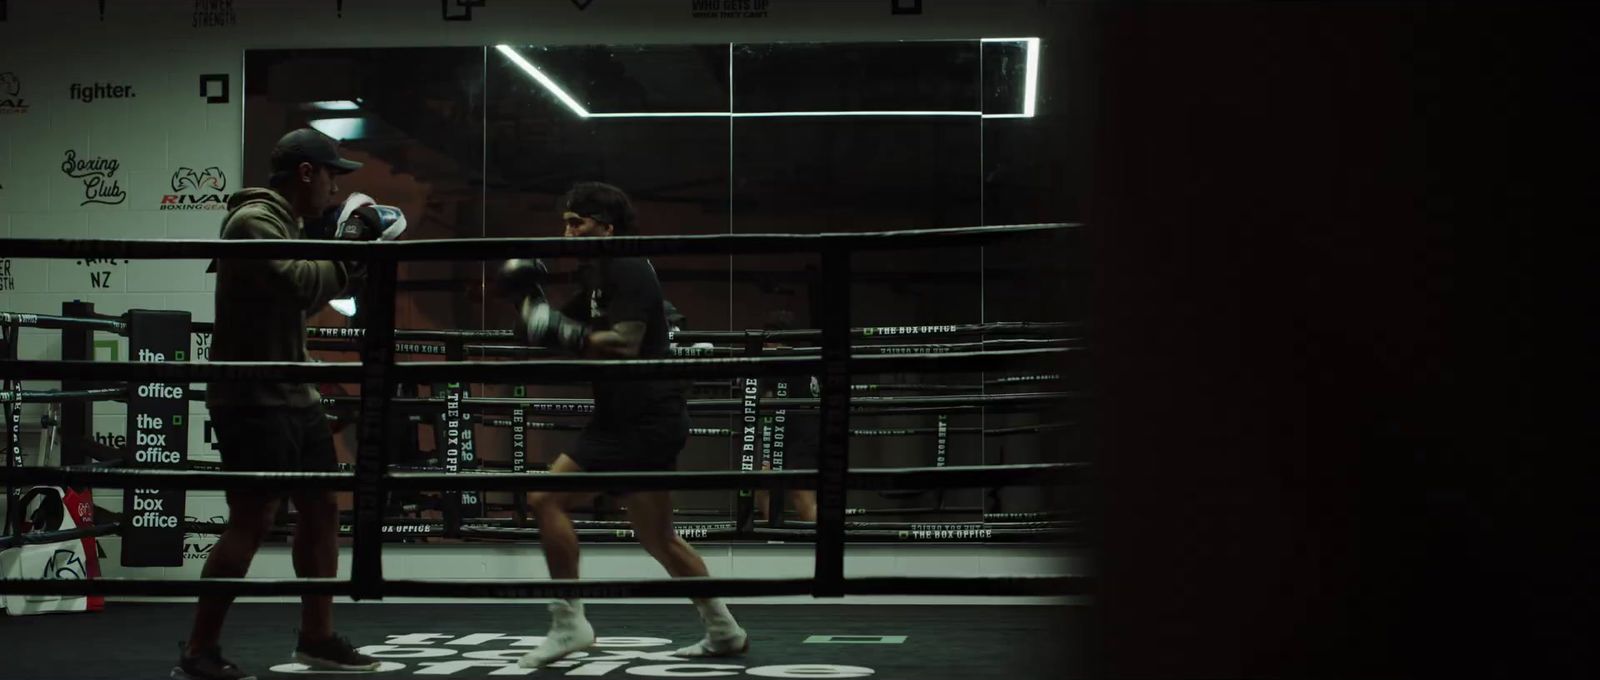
[0,602,1086,680]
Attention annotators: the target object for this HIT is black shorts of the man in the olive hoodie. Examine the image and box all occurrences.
[211,405,339,472]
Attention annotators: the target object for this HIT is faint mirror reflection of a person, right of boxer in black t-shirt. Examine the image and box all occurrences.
[755,309,822,522]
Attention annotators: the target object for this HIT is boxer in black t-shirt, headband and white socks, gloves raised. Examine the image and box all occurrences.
[498,182,749,667]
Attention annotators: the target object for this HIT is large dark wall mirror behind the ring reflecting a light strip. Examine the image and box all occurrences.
[243,38,1085,534]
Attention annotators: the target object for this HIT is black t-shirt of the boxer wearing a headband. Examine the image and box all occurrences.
[563,258,686,429]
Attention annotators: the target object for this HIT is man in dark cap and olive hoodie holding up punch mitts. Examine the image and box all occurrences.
[180,128,405,680]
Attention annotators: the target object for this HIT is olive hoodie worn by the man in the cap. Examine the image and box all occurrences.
[205,189,366,408]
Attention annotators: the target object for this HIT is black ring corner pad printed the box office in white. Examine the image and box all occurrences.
[122,309,189,566]
